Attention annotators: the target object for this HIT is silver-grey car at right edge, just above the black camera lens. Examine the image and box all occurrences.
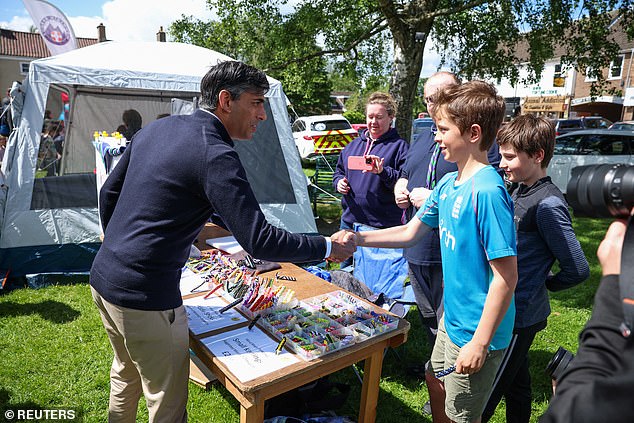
[548,129,634,194]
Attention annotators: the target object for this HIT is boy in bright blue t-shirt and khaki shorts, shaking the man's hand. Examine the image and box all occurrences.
[355,81,517,422]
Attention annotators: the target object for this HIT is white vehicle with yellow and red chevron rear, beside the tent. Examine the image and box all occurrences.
[292,115,358,160]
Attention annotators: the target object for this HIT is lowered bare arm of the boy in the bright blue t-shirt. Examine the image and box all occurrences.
[456,256,517,374]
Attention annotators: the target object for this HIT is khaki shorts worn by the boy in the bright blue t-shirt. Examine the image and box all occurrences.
[430,317,505,422]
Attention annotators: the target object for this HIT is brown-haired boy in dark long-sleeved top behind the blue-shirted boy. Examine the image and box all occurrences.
[482,115,590,423]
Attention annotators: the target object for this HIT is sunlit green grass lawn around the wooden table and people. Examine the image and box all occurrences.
[0,219,609,423]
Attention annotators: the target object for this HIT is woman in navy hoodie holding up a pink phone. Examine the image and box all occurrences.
[332,92,409,268]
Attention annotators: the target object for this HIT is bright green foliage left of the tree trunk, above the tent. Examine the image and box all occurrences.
[169,0,385,115]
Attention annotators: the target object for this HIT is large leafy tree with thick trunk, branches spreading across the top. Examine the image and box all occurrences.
[171,0,634,142]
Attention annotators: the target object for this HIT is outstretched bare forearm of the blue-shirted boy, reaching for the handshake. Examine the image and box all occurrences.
[355,216,431,248]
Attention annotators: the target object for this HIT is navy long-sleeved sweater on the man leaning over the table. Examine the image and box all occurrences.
[90,110,326,310]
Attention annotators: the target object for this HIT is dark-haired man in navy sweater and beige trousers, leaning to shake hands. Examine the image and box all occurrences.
[90,61,354,423]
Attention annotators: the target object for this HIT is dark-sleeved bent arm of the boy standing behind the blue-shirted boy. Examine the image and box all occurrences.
[537,196,590,291]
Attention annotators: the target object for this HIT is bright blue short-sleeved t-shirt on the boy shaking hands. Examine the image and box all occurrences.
[417,166,517,350]
